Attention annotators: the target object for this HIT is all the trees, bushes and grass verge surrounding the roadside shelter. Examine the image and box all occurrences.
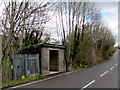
[0,0,116,87]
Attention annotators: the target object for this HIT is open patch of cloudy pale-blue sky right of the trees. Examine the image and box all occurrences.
[97,2,118,41]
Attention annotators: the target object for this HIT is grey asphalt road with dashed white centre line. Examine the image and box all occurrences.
[9,50,120,90]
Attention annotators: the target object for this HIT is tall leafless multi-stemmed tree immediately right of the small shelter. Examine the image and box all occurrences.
[53,1,115,69]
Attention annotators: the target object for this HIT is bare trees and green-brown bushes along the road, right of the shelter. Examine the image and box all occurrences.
[55,2,115,69]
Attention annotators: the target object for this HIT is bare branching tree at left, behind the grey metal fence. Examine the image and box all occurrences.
[1,0,50,81]
